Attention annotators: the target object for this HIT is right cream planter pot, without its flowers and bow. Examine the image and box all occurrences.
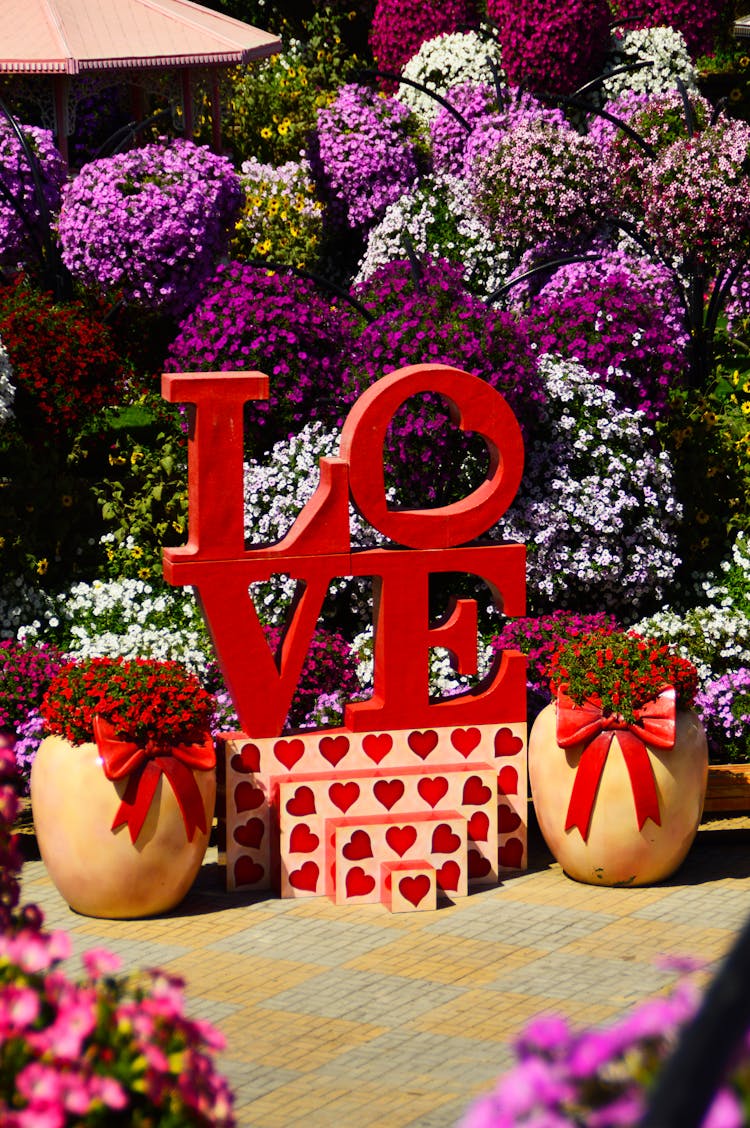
[529,702,708,885]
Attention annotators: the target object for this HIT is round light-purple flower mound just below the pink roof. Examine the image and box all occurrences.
[59,140,242,316]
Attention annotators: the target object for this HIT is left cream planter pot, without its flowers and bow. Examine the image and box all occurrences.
[30,737,217,919]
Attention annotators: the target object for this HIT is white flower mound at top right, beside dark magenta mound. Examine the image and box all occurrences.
[601,27,698,100]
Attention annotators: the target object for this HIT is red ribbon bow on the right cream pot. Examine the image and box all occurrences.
[557,688,674,841]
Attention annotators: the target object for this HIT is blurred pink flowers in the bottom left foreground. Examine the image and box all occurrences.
[0,748,236,1128]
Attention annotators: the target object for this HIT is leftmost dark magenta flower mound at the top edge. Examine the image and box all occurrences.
[370,0,478,84]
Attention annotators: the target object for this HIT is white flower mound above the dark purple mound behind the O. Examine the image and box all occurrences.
[354,173,512,294]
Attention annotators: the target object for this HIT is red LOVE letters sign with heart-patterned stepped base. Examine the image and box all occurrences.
[162,364,526,908]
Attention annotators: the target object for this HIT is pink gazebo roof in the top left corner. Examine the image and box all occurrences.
[0,0,281,74]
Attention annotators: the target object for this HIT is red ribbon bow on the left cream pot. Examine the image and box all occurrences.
[94,716,217,843]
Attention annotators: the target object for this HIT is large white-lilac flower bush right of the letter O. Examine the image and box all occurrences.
[493,355,681,614]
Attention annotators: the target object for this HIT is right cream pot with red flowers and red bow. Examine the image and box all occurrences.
[529,631,708,885]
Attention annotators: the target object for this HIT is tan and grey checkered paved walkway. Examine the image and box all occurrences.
[24,820,750,1128]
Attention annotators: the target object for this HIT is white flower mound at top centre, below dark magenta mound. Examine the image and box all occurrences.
[397,32,500,123]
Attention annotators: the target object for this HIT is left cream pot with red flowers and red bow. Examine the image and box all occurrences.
[32,658,215,918]
